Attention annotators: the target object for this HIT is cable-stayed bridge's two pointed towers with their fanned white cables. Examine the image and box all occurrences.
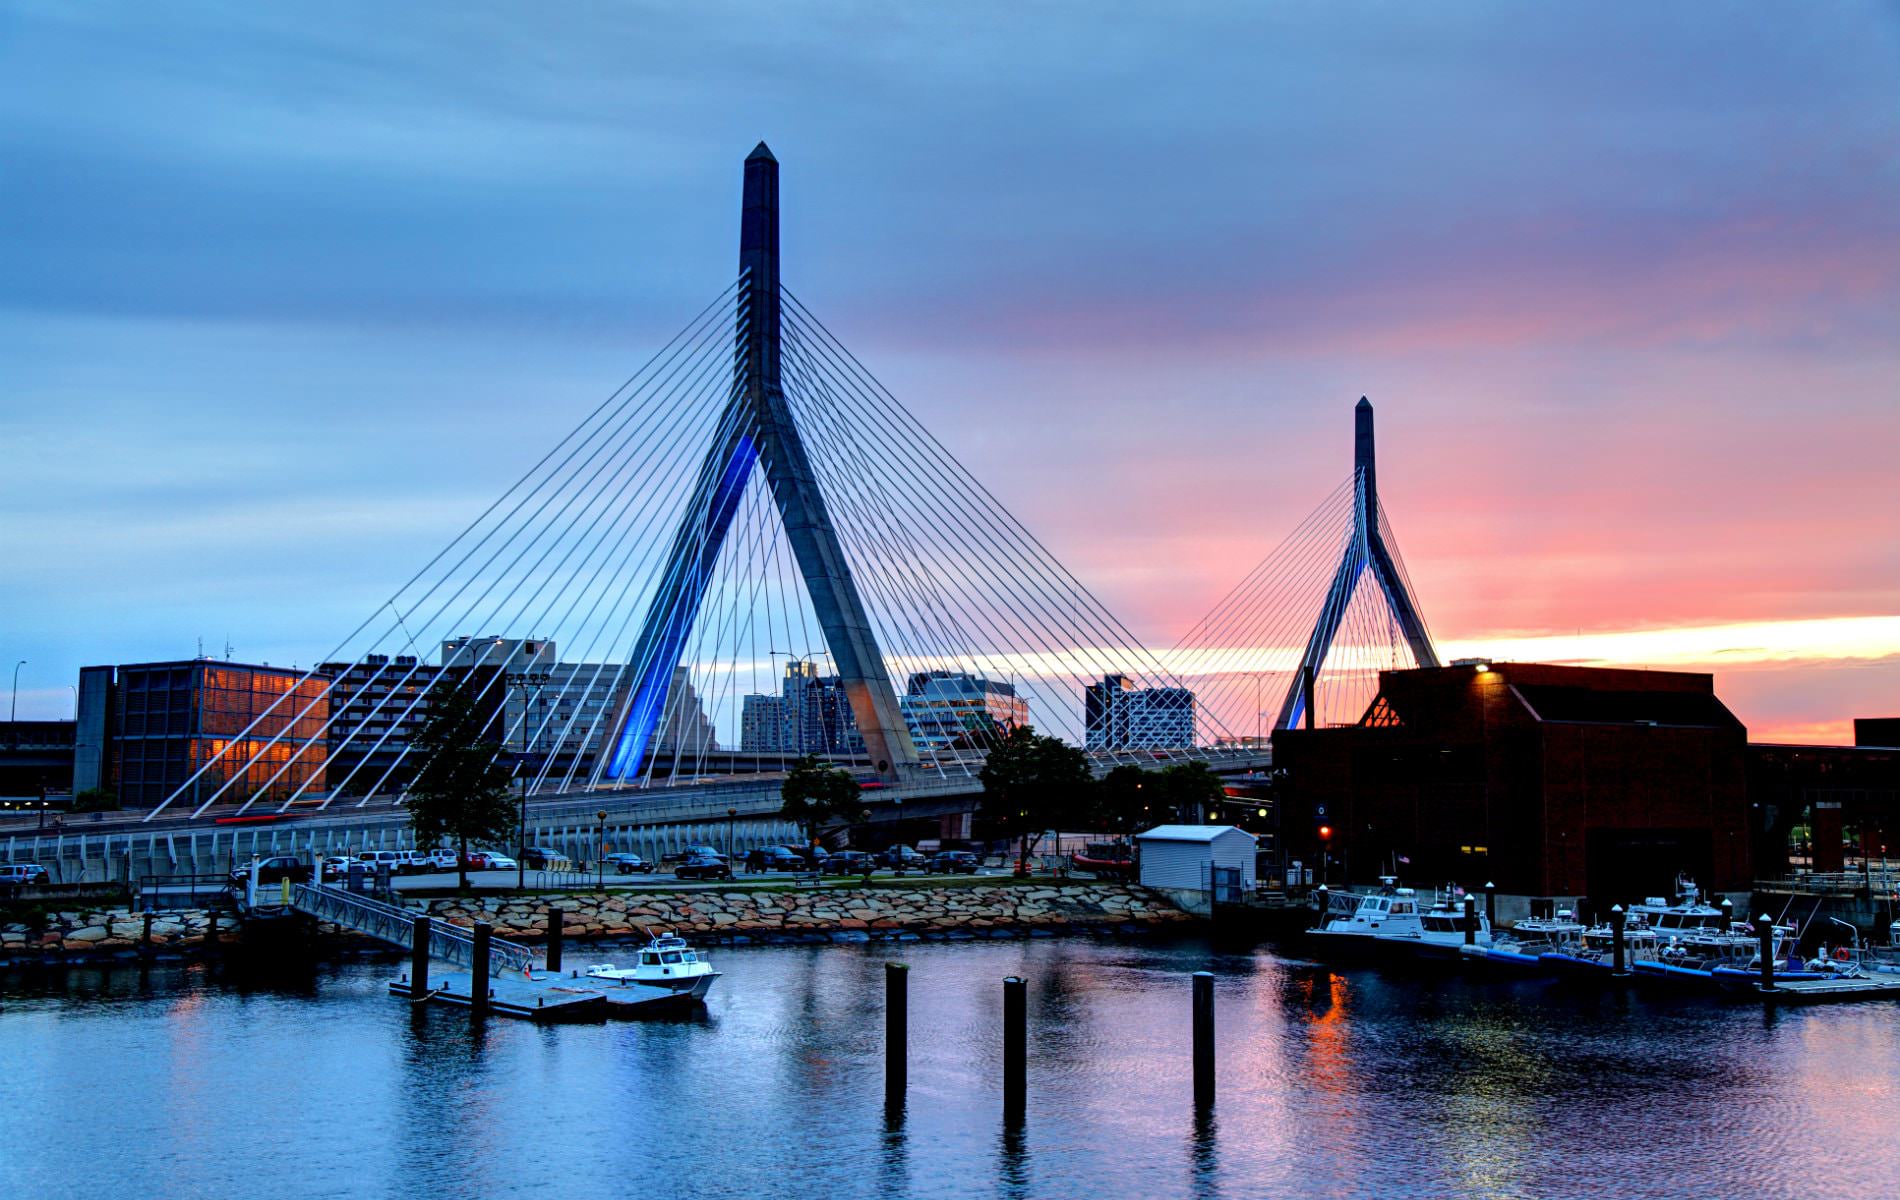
[126,144,1431,824]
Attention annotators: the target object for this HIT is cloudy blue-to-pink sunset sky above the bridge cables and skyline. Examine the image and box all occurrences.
[0,0,1900,741]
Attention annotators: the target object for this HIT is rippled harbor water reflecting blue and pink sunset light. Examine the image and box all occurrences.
[0,938,1900,1200]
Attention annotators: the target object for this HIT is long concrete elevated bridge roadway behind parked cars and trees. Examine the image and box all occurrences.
[0,750,1271,883]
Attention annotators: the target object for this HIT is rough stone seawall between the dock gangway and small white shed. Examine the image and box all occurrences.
[429,883,1189,942]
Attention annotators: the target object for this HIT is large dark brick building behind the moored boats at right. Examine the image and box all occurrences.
[1273,663,1767,915]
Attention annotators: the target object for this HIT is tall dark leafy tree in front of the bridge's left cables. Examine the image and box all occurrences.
[407,687,515,891]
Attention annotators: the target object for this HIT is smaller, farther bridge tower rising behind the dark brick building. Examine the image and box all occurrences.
[1273,397,1438,729]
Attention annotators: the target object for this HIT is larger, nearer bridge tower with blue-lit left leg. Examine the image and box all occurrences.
[597,142,918,780]
